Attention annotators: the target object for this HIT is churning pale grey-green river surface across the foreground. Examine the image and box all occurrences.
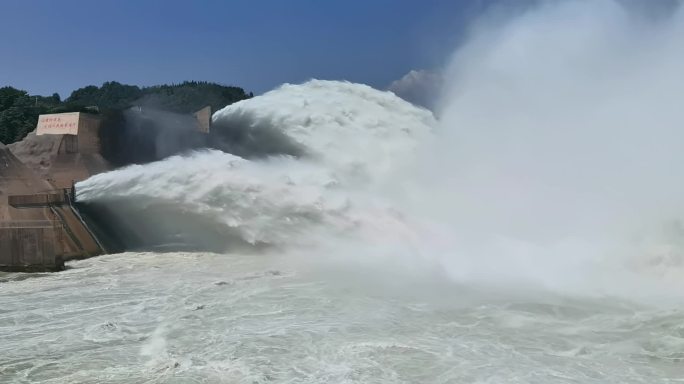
[0,253,684,384]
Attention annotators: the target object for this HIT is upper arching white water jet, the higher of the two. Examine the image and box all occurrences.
[212,80,434,183]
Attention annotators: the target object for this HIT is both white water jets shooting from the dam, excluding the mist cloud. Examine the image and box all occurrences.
[78,80,435,251]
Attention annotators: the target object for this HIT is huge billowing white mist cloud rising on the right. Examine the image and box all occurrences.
[417,0,684,294]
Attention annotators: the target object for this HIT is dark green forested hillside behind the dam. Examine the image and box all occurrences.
[0,81,252,144]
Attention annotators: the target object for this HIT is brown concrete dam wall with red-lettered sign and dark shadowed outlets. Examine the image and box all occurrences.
[0,108,211,272]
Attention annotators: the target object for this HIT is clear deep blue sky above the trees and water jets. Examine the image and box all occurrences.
[0,0,486,98]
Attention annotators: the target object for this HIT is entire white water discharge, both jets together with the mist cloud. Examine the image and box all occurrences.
[78,0,684,296]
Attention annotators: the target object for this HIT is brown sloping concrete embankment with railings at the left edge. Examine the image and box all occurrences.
[0,134,104,272]
